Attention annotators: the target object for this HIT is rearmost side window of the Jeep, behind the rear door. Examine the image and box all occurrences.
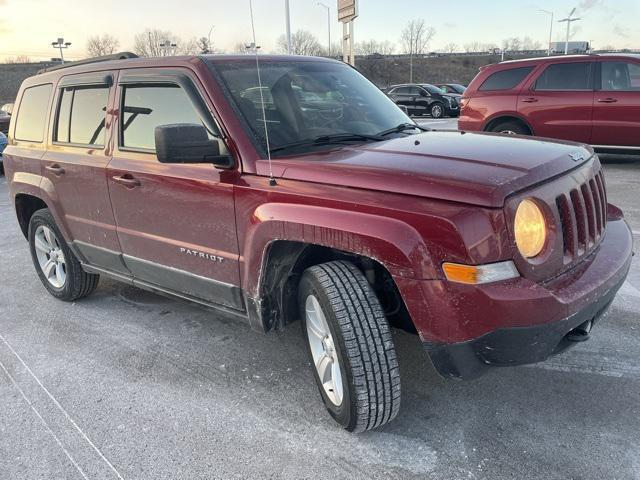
[15,84,51,142]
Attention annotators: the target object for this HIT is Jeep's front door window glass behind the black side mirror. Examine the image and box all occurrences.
[120,85,209,150]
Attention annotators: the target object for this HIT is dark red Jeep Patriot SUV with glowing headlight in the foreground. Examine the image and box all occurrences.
[5,55,632,431]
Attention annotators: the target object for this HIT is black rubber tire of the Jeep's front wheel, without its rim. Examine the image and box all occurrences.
[298,261,400,432]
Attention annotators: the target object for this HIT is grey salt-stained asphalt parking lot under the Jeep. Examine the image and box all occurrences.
[0,125,640,480]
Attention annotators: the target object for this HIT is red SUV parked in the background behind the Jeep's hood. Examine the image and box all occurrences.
[459,55,640,151]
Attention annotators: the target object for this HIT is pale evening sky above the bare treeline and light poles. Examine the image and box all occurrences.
[0,0,640,61]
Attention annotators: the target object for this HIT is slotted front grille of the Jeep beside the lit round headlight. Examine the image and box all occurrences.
[556,171,607,264]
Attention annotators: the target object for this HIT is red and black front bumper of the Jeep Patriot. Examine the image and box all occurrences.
[398,219,633,379]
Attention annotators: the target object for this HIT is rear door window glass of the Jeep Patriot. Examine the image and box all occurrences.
[69,87,109,146]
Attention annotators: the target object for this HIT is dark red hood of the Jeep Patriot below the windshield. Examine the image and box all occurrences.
[257,131,593,207]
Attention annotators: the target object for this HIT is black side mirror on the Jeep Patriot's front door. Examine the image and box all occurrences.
[155,123,234,168]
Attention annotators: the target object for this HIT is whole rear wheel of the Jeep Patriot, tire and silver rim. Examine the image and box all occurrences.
[29,208,100,301]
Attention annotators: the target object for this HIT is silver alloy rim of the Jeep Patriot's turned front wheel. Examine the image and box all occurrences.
[305,295,344,407]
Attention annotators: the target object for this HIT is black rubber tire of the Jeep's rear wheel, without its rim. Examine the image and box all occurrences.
[29,208,100,302]
